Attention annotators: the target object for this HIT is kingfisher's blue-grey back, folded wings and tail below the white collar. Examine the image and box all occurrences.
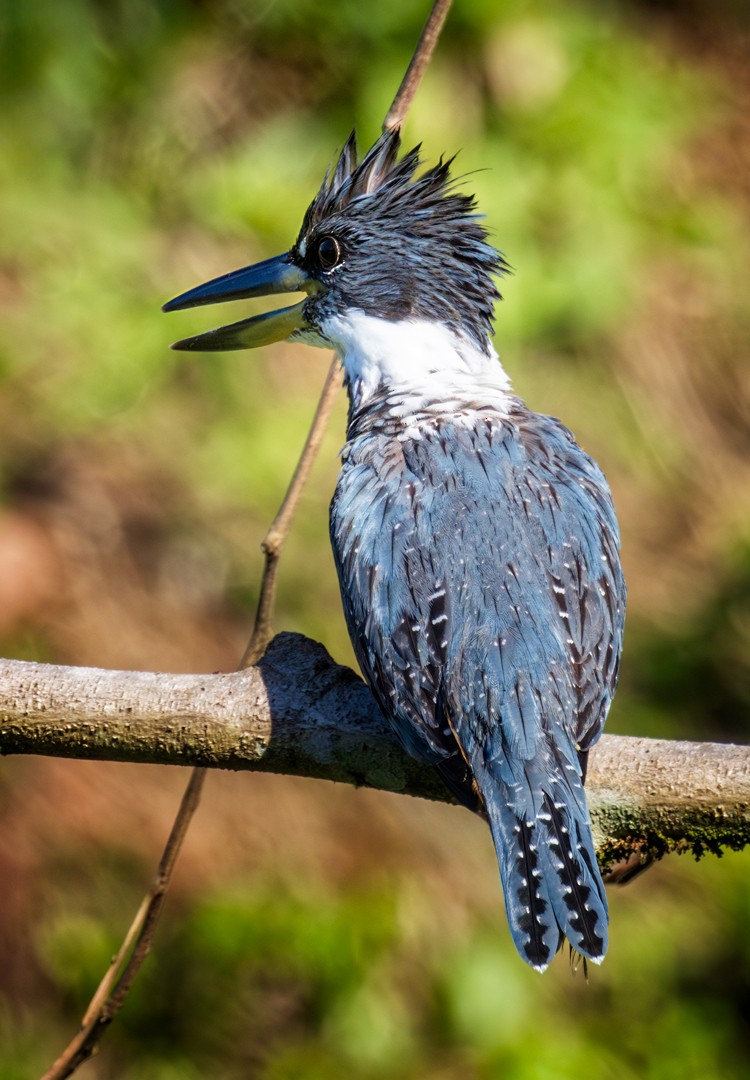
[331,403,625,968]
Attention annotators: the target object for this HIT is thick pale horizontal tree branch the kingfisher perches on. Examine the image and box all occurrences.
[0,634,750,865]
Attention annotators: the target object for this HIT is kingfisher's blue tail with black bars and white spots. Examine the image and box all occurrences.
[480,773,608,971]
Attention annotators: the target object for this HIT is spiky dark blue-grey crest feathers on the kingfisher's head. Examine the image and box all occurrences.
[293,130,509,348]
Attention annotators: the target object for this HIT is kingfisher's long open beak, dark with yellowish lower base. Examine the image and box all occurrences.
[162,252,319,352]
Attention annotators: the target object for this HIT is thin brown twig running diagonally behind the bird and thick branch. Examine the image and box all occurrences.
[42,0,452,1080]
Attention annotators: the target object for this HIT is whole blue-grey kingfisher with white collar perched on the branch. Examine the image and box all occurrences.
[164,131,626,971]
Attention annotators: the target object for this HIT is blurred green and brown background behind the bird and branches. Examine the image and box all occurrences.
[0,0,750,1080]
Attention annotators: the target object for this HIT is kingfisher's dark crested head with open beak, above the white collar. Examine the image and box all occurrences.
[164,131,506,351]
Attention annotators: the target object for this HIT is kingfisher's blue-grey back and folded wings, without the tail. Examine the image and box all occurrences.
[331,414,625,762]
